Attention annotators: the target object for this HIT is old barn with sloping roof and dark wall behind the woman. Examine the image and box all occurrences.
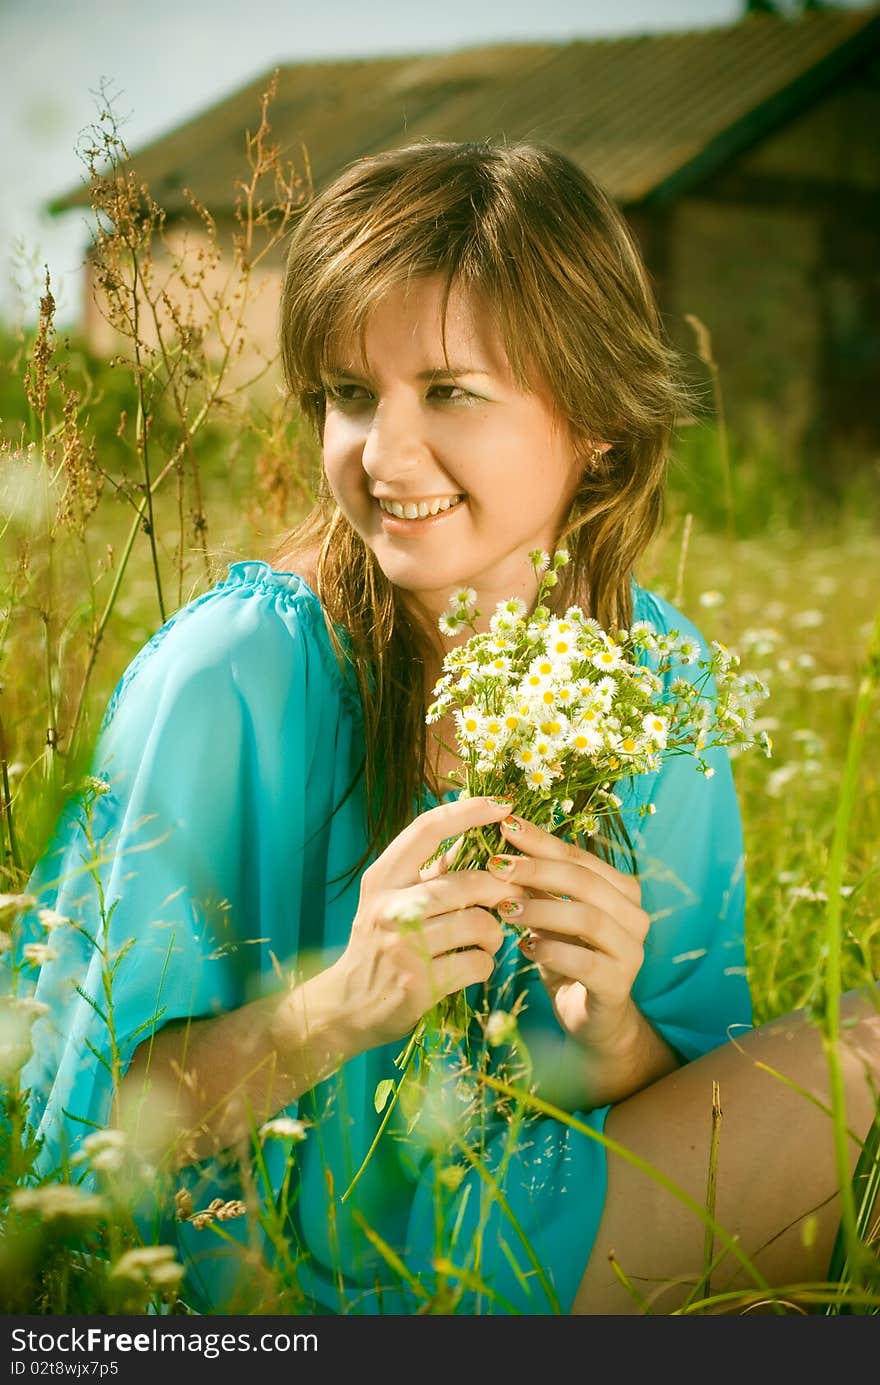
[51,6,880,476]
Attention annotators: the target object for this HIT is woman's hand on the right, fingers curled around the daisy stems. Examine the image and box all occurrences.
[489,817,678,1102]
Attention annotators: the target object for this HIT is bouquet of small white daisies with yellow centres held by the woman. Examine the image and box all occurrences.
[427,550,771,870]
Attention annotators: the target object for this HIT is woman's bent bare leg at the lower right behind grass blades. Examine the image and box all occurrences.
[572,992,880,1314]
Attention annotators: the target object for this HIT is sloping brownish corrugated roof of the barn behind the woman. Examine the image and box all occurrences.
[49,6,880,216]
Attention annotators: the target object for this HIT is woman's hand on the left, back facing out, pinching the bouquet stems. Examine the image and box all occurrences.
[322,798,527,1051]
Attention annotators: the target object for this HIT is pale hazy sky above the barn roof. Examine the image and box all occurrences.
[0,0,869,325]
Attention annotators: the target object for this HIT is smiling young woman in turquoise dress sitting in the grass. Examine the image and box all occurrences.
[15,143,880,1313]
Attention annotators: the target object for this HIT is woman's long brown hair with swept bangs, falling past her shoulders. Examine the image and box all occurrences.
[270,140,694,868]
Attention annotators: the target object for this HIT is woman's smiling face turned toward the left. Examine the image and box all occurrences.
[323,276,582,631]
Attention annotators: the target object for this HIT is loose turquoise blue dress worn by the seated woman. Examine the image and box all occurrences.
[10,561,751,1314]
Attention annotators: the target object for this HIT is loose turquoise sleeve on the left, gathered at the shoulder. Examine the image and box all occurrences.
[6,562,351,1307]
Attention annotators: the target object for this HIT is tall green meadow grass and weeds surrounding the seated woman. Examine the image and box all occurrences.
[0,83,880,1313]
